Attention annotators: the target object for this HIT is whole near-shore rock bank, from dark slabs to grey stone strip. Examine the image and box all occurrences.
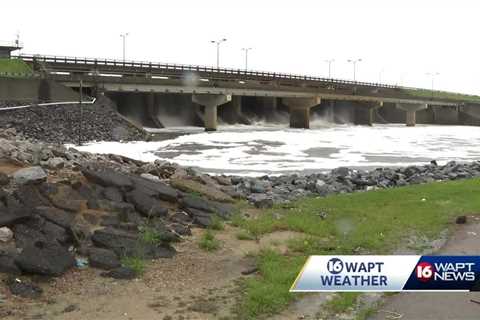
[0,128,480,297]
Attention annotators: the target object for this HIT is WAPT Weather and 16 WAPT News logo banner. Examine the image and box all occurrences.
[290,255,480,292]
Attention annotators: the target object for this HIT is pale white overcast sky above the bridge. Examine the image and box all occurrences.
[0,0,480,94]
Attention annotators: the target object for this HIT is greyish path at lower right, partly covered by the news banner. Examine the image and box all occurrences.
[370,217,480,320]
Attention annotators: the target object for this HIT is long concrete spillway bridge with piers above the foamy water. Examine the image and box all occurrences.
[10,55,478,130]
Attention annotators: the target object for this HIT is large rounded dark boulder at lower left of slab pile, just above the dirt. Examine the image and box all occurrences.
[15,241,75,276]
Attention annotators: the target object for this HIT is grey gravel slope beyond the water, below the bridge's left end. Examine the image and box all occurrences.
[0,98,146,144]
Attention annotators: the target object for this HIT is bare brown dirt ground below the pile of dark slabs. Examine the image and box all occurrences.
[0,226,308,320]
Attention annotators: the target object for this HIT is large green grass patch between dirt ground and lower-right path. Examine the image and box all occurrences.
[236,179,480,319]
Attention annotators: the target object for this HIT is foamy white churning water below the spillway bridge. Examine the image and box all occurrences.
[77,124,480,175]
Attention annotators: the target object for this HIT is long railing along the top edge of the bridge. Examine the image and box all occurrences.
[14,54,399,89]
